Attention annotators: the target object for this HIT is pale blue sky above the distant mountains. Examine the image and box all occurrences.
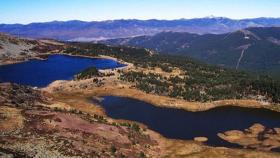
[0,0,280,24]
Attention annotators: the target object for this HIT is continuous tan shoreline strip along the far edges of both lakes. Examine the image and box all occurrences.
[0,53,280,112]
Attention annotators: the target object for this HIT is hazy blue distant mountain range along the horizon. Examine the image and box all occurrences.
[0,17,280,41]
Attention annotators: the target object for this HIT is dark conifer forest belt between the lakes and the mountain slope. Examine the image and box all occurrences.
[64,43,280,103]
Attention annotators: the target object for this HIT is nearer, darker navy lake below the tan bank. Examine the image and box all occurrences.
[100,96,280,147]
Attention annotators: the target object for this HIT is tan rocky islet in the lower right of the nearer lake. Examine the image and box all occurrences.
[218,123,280,151]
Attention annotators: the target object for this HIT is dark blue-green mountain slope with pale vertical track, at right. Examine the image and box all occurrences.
[103,27,280,78]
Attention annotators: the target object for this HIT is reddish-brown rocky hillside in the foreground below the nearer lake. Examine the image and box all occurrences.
[0,84,279,158]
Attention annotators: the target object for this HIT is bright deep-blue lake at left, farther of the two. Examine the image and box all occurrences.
[0,55,126,87]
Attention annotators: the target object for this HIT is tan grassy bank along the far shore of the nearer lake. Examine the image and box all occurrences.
[43,75,280,112]
